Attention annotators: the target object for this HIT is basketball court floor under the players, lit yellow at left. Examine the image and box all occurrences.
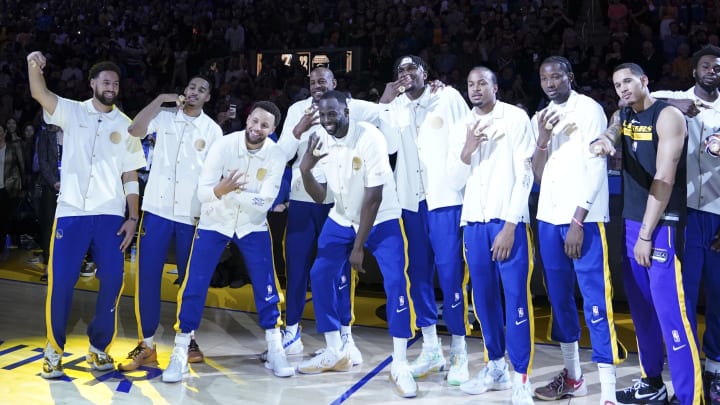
[0,250,688,405]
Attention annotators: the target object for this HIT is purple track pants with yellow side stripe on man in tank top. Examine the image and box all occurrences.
[623,219,703,404]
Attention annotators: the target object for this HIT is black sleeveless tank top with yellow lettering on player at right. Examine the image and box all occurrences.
[620,100,687,224]
